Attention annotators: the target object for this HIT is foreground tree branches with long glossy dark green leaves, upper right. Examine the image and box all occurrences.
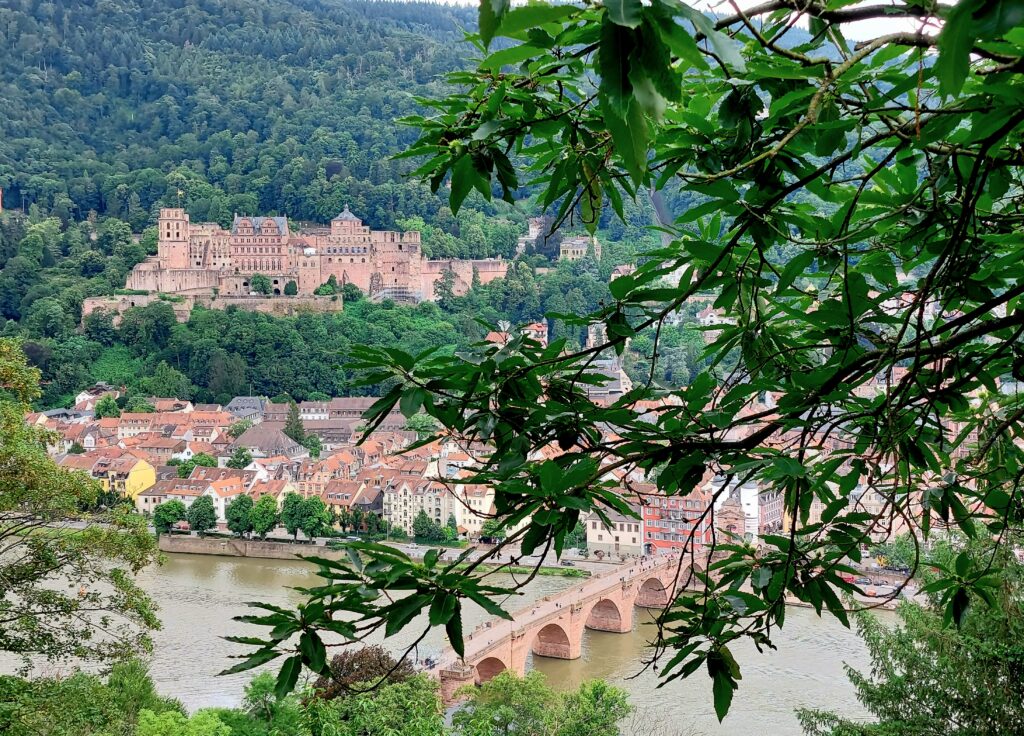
[232,0,1024,717]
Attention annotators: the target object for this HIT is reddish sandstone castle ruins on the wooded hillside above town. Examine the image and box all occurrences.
[125,206,508,302]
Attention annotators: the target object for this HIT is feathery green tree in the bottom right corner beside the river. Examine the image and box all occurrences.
[799,533,1024,736]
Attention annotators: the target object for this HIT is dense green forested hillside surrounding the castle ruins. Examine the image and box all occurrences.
[0,0,702,407]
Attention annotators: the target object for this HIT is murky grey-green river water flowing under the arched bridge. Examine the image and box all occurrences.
[61,555,891,736]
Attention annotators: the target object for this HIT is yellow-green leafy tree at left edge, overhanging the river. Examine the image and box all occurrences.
[0,338,158,663]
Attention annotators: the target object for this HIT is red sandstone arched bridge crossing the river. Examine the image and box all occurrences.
[430,555,689,703]
